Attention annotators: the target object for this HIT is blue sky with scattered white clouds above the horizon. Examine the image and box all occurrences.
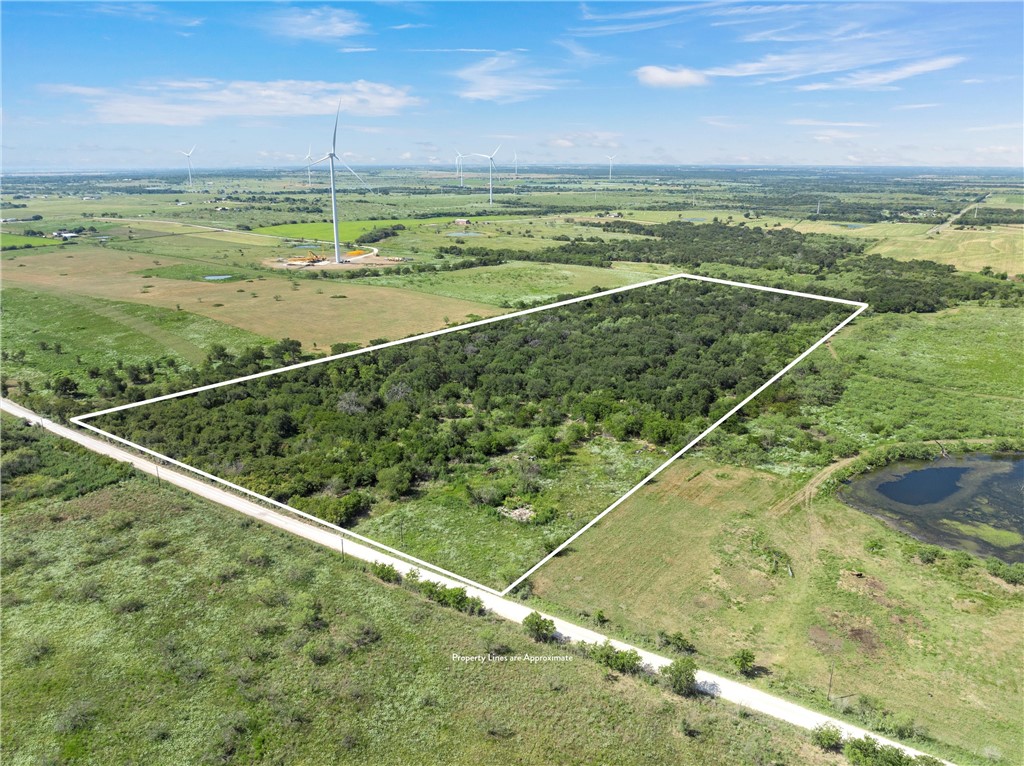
[0,0,1024,171]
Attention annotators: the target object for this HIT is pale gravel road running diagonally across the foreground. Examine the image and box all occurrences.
[0,399,953,766]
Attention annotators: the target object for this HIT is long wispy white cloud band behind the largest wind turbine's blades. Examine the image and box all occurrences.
[43,79,422,125]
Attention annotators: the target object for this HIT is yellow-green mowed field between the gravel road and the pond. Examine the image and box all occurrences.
[534,458,1024,763]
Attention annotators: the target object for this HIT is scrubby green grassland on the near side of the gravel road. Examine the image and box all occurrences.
[0,417,843,766]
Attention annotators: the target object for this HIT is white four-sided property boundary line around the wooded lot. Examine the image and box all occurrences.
[70,272,867,596]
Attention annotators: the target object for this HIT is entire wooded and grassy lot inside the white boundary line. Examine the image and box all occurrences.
[97,280,847,585]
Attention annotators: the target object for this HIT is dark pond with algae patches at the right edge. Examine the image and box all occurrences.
[839,453,1024,563]
